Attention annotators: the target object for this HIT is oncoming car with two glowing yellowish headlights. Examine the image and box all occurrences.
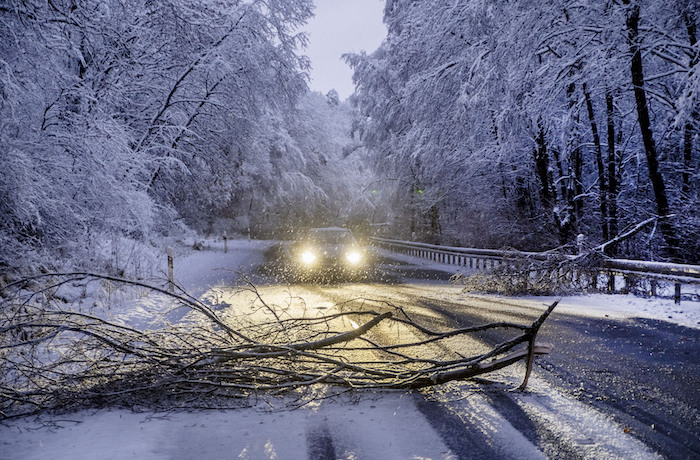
[291,227,372,279]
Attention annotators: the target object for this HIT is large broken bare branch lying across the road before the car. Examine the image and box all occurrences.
[0,273,556,418]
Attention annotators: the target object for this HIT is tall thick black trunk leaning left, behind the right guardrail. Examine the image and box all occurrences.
[627,4,679,259]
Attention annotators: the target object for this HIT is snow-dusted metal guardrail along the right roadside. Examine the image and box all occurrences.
[371,238,700,303]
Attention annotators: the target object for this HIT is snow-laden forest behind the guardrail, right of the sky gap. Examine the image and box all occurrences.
[345,0,700,263]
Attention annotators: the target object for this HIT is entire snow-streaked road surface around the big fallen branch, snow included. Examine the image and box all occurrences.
[0,241,700,460]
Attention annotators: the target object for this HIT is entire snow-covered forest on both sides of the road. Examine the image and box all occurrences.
[0,0,700,272]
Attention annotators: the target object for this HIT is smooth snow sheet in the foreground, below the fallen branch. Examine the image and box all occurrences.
[0,394,460,460]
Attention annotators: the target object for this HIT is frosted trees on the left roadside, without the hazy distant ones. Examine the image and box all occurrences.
[0,0,312,272]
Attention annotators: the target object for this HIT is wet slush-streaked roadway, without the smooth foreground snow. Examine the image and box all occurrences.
[253,250,700,459]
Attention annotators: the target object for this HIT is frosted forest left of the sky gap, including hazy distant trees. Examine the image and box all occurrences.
[0,0,378,271]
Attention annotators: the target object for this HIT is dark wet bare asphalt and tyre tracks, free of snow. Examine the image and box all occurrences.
[260,250,700,459]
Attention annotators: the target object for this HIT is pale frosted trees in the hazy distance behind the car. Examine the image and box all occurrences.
[245,92,376,236]
